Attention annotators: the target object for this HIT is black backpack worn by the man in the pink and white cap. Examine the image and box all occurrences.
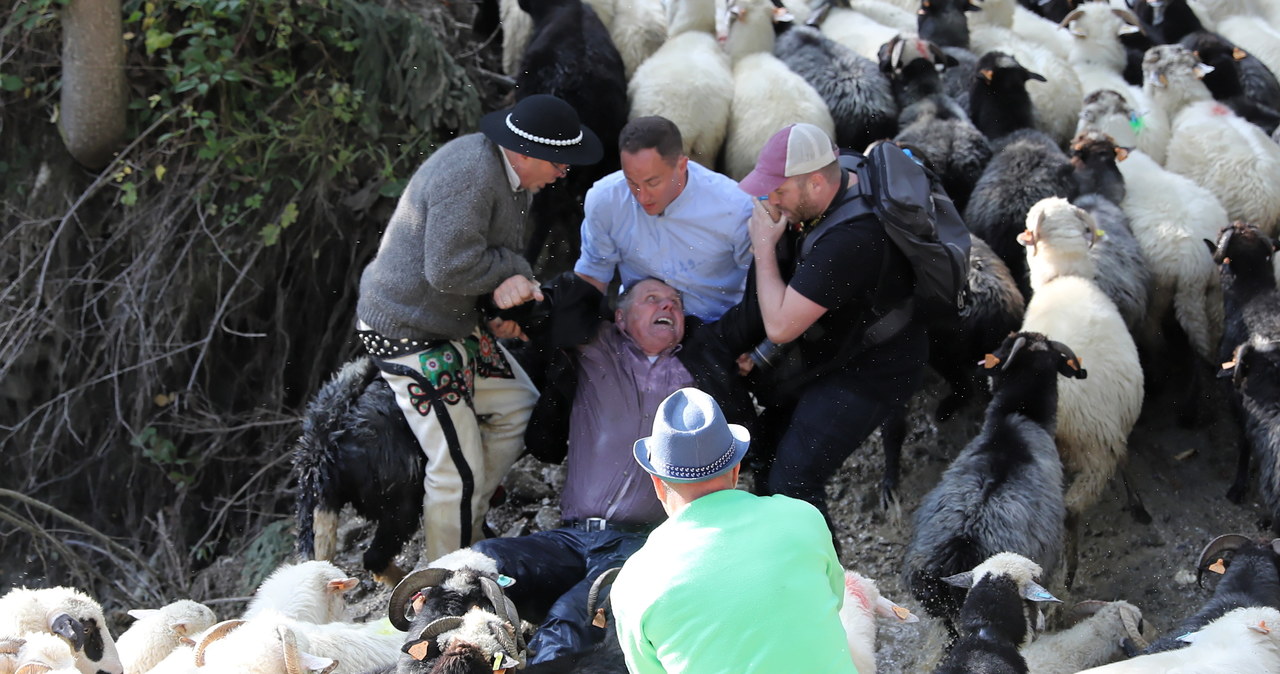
[800,141,972,347]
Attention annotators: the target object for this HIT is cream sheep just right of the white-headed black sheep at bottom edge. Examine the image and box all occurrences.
[1021,601,1147,674]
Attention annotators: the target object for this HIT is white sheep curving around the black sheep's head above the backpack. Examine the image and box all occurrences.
[966,0,1084,146]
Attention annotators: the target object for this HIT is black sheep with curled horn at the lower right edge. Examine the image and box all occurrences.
[1142,533,1280,655]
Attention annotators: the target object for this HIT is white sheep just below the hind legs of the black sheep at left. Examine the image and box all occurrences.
[243,560,360,623]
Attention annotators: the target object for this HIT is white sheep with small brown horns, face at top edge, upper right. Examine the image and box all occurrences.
[1062,3,1169,164]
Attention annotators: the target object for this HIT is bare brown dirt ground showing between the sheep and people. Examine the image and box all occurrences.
[322,365,1266,673]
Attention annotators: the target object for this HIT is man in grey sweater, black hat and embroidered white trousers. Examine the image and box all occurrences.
[356,95,602,559]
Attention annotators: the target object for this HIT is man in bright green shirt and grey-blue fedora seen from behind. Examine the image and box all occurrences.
[612,389,856,674]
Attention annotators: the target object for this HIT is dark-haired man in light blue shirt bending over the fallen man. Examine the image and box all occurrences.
[573,116,751,321]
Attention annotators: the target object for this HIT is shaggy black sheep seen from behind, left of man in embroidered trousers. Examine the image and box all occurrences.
[293,357,426,584]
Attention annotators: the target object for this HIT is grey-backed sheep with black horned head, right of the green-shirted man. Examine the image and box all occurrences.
[902,333,1085,631]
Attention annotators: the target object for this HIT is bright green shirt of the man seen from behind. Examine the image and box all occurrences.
[611,490,856,674]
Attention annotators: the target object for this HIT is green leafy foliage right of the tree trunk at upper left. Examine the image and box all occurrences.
[120,0,480,239]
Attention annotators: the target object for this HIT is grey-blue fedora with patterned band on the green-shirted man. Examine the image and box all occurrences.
[635,389,751,482]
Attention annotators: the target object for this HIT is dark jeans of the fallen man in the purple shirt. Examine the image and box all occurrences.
[471,528,646,664]
